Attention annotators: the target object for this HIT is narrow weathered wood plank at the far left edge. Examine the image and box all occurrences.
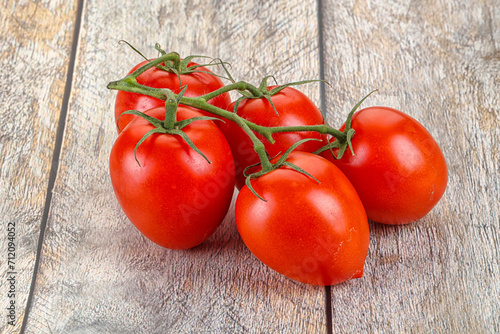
[0,1,76,333]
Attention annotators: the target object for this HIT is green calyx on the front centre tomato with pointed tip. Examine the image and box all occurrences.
[243,138,321,202]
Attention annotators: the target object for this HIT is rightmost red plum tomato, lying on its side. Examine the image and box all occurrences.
[322,107,448,225]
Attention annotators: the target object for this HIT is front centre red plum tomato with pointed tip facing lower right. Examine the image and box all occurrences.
[235,152,369,285]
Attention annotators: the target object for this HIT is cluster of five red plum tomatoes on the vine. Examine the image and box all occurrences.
[106,50,448,285]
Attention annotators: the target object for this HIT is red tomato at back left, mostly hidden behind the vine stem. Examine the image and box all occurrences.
[115,60,231,133]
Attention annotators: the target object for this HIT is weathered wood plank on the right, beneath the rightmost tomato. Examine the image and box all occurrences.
[323,0,500,333]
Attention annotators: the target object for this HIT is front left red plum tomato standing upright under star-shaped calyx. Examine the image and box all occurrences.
[109,106,234,249]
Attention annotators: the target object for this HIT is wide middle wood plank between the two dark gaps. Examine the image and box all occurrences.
[27,0,326,333]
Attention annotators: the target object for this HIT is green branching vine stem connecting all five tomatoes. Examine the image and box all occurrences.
[107,50,371,198]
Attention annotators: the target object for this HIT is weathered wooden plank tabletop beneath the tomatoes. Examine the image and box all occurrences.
[0,0,500,333]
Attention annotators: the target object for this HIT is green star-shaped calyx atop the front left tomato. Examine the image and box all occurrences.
[122,86,220,166]
